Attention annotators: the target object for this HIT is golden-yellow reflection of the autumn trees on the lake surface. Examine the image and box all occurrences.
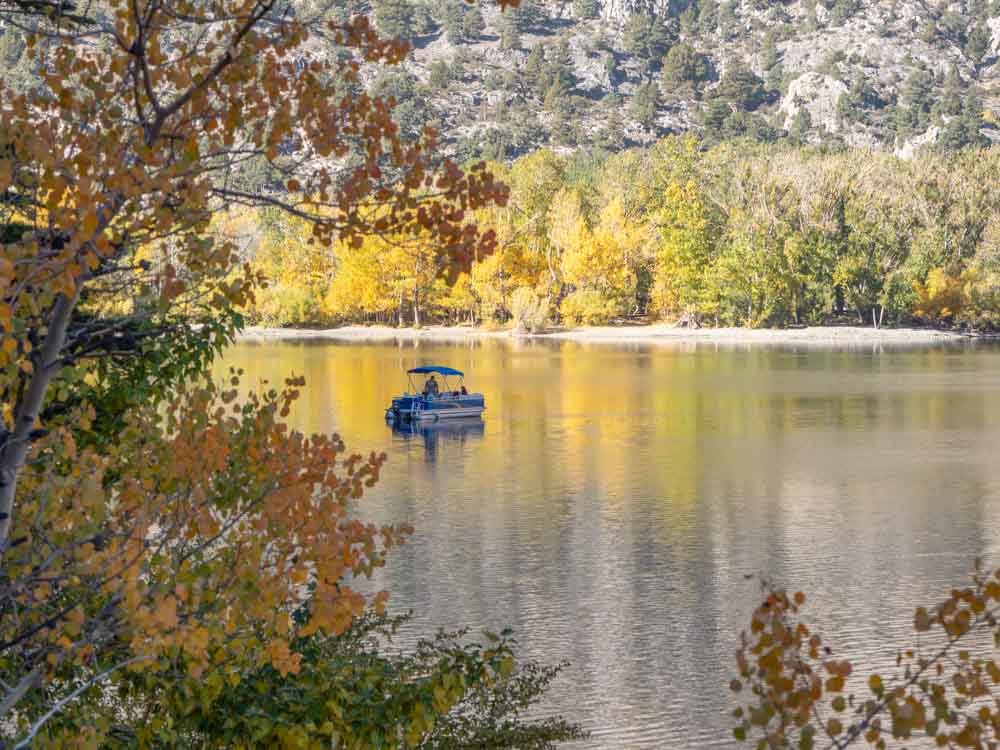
[218,339,1000,546]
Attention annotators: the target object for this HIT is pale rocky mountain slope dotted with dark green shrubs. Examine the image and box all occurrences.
[371,0,1000,158]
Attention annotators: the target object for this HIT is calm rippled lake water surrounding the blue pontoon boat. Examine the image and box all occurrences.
[220,340,1000,748]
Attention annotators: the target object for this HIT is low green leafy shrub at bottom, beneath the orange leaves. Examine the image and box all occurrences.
[111,613,584,750]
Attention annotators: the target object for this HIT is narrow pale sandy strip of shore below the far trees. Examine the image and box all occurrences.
[241,324,984,345]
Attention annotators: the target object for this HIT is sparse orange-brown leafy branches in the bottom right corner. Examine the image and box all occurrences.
[731,563,1000,750]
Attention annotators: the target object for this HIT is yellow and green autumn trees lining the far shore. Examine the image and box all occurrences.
[234,137,1000,332]
